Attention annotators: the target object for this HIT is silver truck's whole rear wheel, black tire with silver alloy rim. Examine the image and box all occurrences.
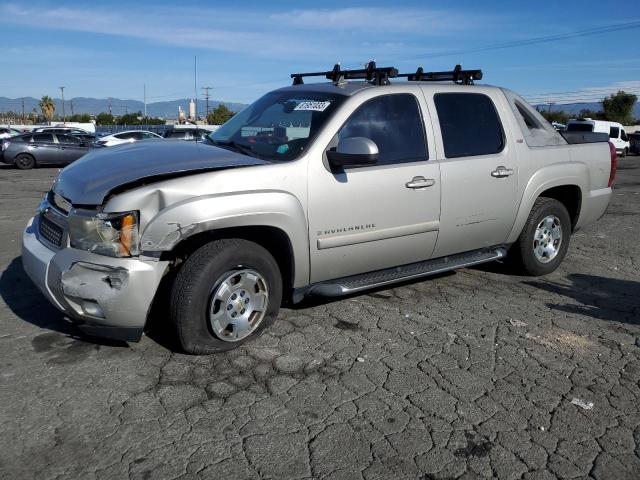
[509,197,571,276]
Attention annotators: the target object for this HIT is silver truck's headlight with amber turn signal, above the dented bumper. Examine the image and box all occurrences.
[69,212,139,257]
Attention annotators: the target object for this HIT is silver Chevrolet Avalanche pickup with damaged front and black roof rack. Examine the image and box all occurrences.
[22,64,616,354]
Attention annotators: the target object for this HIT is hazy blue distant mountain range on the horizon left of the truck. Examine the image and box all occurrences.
[0,97,245,118]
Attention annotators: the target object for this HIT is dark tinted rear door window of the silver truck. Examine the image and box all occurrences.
[433,93,504,158]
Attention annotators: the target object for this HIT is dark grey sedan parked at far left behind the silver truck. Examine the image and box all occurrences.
[0,133,92,170]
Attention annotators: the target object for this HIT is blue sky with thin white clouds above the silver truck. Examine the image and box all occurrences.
[0,0,640,103]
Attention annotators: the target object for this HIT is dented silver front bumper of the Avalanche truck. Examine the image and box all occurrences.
[22,217,168,341]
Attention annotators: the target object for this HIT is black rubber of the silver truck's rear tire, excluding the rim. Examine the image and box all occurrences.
[519,198,571,276]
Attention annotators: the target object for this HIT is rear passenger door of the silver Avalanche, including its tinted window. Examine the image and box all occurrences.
[429,89,518,257]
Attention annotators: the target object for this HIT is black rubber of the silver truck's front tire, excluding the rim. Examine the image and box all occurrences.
[171,239,282,353]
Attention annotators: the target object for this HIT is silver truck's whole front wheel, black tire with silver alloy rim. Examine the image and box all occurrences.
[170,239,282,354]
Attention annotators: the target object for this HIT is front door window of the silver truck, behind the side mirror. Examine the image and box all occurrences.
[338,93,429,165]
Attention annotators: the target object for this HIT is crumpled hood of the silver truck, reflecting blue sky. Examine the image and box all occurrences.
[53,140,269,205]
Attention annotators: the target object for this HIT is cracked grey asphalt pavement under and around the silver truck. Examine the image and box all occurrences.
[0,157,640,480]
